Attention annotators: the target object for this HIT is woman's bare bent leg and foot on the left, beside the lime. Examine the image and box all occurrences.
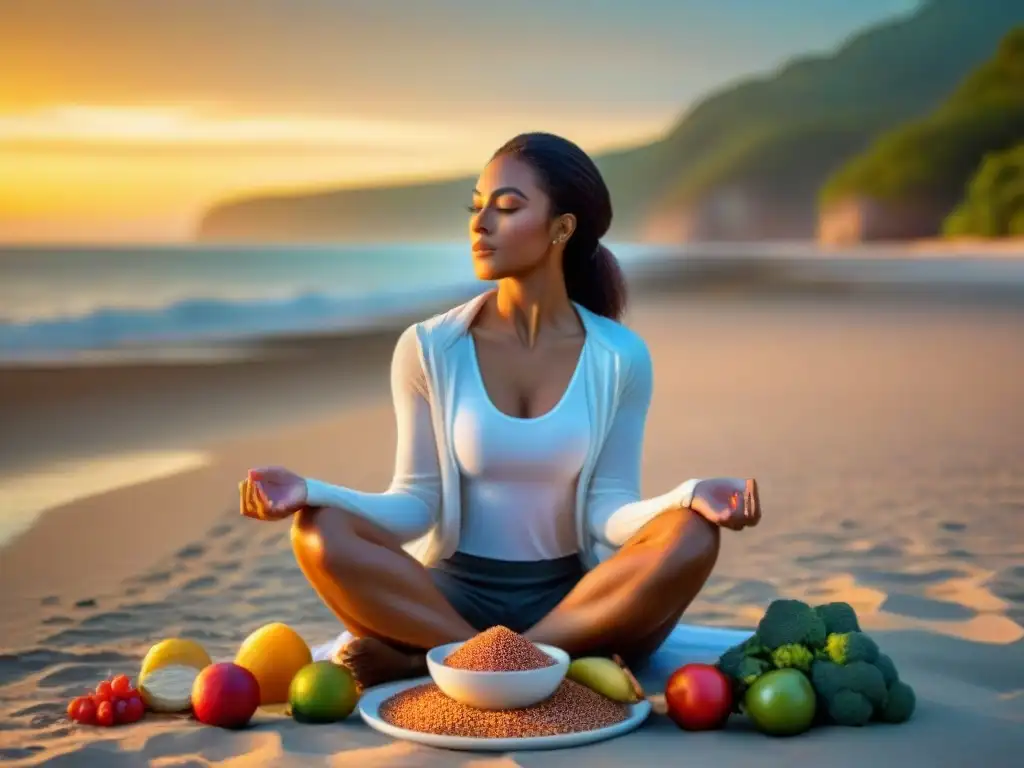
[292,507,476,686]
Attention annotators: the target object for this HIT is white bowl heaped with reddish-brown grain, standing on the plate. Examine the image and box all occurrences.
[427,642,569,710]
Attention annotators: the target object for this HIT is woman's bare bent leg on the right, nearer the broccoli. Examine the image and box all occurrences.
[526,509,720,660]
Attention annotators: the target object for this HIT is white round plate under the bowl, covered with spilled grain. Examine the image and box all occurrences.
[359,677,650,752]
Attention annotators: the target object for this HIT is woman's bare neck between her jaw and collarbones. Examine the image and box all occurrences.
[495,270,578,347]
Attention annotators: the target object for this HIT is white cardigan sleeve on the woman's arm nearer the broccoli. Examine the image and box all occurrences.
[587,339,698,548]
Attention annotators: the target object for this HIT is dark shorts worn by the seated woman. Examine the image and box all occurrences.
[430,552,585,633]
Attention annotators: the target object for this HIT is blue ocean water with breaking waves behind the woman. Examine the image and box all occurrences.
[0,243,671,361]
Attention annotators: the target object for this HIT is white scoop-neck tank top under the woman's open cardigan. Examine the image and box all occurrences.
[453,337,591,560]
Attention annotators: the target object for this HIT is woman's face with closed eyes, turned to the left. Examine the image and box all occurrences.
[469,156,559,281]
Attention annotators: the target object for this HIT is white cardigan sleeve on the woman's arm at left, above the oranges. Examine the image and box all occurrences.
[306,327,441,544]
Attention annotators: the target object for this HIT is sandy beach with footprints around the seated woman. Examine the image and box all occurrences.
[0,292,1024,768]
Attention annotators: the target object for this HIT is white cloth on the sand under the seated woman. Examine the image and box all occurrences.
[312,624,752,690]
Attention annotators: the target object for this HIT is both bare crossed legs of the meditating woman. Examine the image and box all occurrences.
[292,508,720,686]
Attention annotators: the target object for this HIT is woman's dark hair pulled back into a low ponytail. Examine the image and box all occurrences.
[494,133,627,321]
